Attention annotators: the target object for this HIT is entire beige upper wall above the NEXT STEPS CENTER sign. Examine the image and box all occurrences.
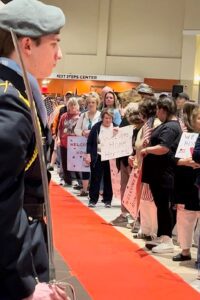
[43,0,200,80]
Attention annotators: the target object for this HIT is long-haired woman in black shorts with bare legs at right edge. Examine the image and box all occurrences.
[173,102,200,261]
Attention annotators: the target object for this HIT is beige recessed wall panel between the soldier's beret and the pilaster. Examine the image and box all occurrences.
[44,0,100,55]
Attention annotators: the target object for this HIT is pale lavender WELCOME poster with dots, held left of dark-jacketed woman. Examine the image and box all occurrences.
[67,136,90,172]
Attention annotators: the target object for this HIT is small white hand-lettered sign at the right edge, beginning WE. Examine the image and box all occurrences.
[175,132,199,158]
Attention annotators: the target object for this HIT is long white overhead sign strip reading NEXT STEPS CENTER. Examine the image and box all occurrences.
[49,73,144,82]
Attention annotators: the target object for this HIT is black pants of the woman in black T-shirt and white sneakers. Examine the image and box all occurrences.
[149,183,173,237]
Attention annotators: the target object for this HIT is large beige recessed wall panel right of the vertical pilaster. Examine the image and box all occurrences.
[108,0,185,57]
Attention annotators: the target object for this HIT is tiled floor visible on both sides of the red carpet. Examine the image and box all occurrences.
[52,172,200,300]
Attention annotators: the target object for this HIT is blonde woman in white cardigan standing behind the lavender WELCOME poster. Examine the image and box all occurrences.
[74,92,101,197]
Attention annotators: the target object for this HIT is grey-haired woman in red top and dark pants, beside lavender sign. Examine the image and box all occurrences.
[57,97,79,186]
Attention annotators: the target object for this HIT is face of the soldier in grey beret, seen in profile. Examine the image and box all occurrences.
[22,34,62,78]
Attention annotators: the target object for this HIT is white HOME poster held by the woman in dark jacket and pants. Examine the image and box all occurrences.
[101,125,133,161]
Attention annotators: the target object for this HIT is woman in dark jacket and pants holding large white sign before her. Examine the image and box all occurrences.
[87,108,115,208]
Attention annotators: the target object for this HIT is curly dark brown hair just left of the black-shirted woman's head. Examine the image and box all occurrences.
[138,97,157,119]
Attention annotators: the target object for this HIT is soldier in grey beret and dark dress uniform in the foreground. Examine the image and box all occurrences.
[0,0,65,300]
